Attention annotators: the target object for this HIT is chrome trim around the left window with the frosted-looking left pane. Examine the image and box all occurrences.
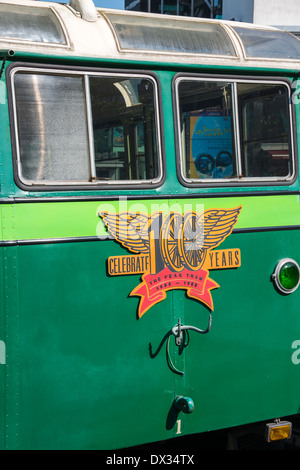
[9,65,165,191]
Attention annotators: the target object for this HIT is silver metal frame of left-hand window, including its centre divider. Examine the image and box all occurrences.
[6,62,166,192]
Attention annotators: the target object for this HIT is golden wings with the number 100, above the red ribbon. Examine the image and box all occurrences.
[99,206,242,274]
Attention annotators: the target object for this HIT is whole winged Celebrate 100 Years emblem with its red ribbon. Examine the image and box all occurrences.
[99,206,242,318]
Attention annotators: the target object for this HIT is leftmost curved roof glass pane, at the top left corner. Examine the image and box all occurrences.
[0,3,66,44]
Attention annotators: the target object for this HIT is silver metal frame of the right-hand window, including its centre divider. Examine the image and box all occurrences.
[172,73,298,188]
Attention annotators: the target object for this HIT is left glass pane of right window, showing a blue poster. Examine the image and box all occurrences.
[179,81,236,179]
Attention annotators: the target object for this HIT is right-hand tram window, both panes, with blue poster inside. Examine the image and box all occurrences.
[177,78,293,184]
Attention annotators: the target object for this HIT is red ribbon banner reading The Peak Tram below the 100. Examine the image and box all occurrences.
[129,268,219,318]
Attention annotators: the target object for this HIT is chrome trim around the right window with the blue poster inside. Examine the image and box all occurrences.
[173,74,296,187]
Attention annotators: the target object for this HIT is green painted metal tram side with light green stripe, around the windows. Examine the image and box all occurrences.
[0,46,300,450]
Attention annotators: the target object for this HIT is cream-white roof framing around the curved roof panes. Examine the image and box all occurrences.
[0,0,300,70]
